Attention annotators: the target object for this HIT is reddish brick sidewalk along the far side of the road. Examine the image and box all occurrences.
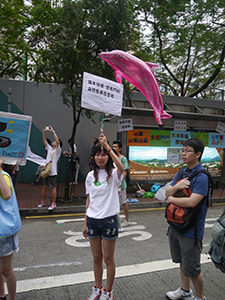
[15,182,225,215]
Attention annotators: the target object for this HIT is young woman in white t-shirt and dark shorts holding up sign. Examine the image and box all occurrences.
[82,133,123,300]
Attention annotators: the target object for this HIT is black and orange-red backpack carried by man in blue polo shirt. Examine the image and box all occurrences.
[165,169,213,237]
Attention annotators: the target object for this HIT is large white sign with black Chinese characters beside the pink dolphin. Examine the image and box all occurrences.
[81,72,123,116]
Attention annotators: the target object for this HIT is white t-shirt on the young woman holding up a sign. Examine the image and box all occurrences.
[85,169,123,219]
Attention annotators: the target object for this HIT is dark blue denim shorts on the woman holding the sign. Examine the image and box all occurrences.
[87,215,118,241]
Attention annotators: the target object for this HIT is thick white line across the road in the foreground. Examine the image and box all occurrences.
[12,254,211,293]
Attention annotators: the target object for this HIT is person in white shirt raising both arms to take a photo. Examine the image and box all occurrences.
[38,126,62,210]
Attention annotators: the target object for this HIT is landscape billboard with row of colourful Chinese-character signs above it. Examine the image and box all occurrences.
[128,130,225,181]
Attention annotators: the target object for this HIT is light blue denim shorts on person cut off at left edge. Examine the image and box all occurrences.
[0,234,19,257]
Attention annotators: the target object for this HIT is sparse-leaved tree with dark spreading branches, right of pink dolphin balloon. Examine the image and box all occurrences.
[138,0,225,97]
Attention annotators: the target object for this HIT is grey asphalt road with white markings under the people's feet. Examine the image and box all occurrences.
[8,203,225,300]
